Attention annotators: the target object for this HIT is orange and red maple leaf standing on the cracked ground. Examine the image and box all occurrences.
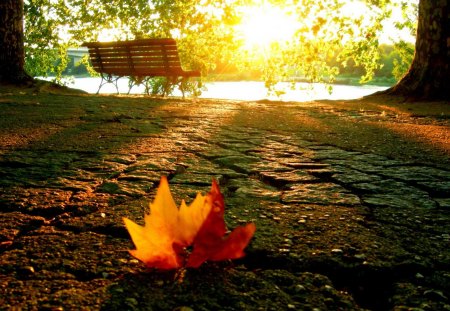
[124,176,256,269]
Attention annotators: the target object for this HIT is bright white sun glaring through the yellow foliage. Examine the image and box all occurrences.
[236,3,298,48]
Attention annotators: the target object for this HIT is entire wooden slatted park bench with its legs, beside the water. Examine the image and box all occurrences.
[83,38,200,97]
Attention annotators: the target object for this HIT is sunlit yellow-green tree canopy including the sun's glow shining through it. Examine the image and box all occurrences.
[25,0,417,92]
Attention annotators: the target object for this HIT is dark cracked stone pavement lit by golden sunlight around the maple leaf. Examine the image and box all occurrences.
[0,98,450,310]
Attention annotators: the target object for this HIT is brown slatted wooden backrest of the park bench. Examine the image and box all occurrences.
[83,39,188,76]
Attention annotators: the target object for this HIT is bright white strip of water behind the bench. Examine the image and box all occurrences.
[69,78,387,101]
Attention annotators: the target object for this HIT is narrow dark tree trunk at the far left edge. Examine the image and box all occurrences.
[0,0,32,83]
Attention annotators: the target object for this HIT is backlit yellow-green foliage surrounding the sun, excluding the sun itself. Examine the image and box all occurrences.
[20,0,398,87]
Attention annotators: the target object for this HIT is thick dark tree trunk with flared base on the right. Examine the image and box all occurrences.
[382,0,450,100]
